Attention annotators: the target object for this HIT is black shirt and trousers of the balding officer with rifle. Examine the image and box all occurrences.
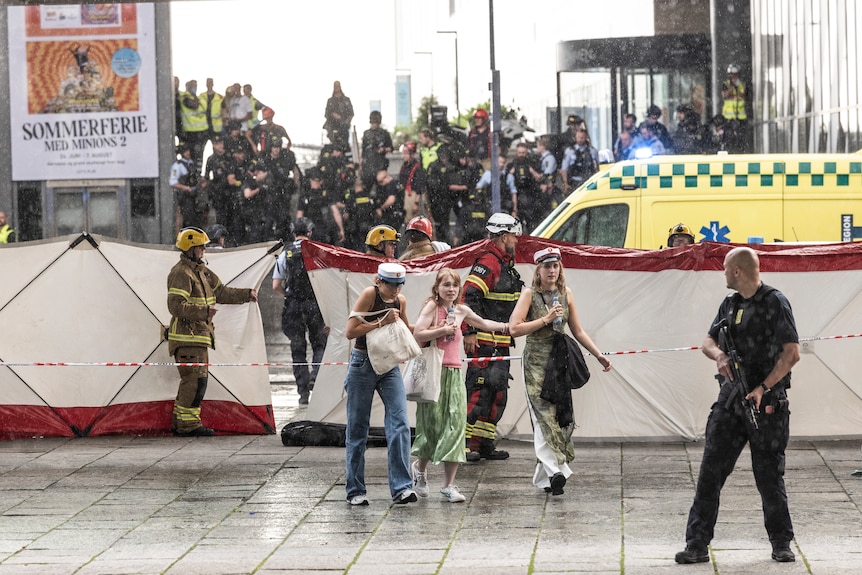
[685,284,799,549]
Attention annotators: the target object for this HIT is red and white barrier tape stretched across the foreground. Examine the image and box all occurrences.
[0,333,862,367]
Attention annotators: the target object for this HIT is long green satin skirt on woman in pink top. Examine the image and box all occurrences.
[411,366,467,464]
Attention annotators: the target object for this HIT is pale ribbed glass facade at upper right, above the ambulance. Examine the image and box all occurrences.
[751,0,862,153]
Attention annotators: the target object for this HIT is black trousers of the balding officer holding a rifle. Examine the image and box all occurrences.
[685,385,793,547]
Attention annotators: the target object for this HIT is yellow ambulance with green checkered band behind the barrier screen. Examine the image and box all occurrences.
[532,154,862,249]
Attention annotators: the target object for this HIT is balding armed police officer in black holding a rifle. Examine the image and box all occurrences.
[676,247,799,563]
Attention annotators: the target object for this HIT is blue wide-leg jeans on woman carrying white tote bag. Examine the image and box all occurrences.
[344,349,413,499]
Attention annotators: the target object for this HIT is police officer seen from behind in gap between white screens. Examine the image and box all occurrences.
[272,218,329,405]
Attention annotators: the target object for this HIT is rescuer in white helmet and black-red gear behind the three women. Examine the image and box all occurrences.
[464,213,524,461]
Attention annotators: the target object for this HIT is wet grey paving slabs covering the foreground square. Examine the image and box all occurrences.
[0,382,862,575]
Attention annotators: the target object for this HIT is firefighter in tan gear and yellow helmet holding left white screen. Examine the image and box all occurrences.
[168,228,257,436]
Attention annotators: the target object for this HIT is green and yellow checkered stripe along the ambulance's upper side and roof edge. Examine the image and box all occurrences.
[587,160,862,190]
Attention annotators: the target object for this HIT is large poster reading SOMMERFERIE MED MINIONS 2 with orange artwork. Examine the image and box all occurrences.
[8,3,158,180]
